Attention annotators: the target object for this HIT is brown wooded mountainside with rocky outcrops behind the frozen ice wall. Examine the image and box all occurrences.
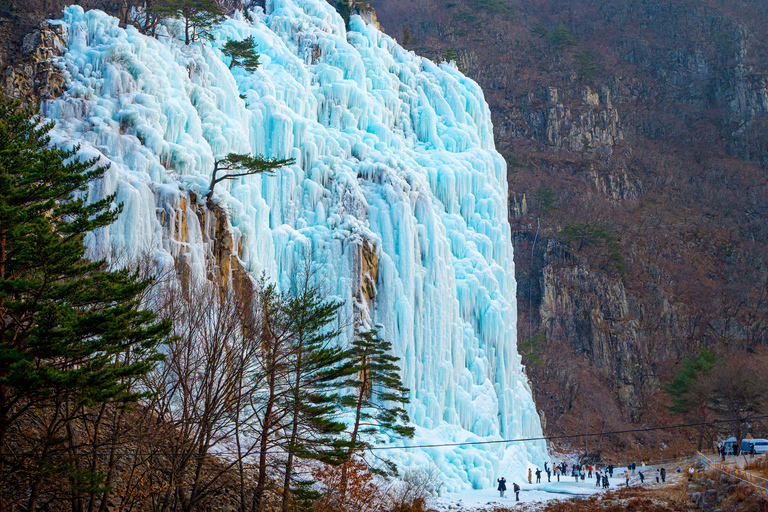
[372,0,768,436]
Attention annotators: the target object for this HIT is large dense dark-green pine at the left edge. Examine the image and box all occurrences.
[0,98,169,510]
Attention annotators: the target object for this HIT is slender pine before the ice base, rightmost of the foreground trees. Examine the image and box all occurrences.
[341,327,414,491]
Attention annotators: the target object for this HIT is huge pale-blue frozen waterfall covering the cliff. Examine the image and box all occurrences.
[43,0,546,490]
